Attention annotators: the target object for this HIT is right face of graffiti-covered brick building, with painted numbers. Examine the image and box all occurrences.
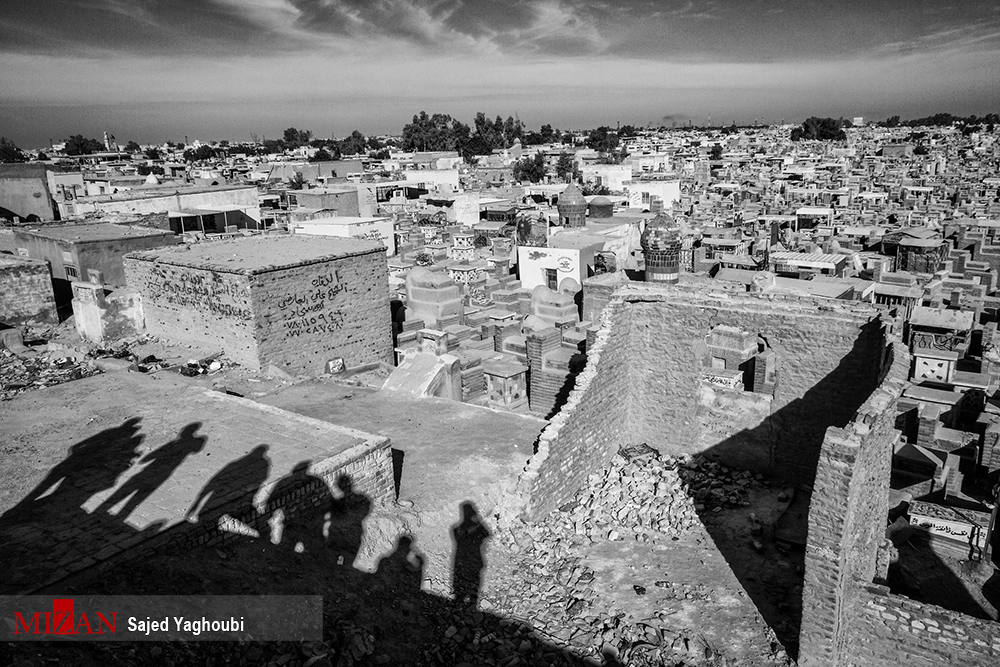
[250,247,393,375]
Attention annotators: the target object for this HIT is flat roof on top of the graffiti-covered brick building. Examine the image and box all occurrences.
[126,235,385,275]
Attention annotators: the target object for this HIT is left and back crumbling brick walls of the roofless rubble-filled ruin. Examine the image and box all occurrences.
[522,282,885,518]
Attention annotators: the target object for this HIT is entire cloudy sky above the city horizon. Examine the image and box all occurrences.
[0,0,1000,148]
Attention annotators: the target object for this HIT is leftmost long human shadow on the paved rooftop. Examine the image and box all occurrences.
[0,418,143,592]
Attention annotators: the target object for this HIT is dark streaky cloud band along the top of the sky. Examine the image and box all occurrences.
[0,0,1000,62]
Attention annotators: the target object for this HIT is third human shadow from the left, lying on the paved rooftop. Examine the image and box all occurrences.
[185,445,271,528]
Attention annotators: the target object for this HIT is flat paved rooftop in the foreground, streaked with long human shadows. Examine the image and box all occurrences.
[0,373,384,593]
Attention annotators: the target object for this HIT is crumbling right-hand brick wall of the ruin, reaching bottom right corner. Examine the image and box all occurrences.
[799,349,1000,667]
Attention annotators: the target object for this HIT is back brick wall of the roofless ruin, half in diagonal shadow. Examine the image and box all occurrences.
[623,284,885,483]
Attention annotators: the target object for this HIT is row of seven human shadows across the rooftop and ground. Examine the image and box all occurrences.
[0,418,490,620]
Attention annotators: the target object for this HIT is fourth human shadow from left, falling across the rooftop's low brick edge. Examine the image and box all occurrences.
[266,461,333,559]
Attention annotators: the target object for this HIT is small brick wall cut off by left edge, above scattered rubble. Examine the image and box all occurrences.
[0,256,59,325]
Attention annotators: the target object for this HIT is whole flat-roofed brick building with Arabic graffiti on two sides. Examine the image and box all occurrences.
[125,235,392,375]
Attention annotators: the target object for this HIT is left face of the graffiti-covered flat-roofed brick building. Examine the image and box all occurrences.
[124,256,260,370]
